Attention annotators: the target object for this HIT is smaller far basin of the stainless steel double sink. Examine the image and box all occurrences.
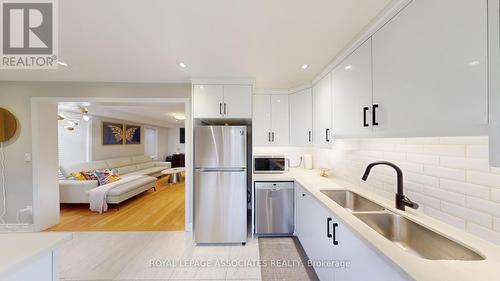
[321,190,385,212]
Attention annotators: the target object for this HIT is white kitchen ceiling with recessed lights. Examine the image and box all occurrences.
[0,0,390,88]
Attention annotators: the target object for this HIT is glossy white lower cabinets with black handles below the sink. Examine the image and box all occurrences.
[295,183,408,281]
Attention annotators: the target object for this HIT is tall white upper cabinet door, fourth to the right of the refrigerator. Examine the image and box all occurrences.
[313,73,332,147]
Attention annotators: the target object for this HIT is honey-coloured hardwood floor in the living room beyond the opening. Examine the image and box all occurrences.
[47,177,185,231]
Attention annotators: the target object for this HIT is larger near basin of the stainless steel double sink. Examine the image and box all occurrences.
[354,212,484,261]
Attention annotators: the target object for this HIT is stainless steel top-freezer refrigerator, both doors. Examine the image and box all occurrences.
[194,126,248,243]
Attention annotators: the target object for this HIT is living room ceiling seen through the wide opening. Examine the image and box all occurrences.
[59,102,185,128]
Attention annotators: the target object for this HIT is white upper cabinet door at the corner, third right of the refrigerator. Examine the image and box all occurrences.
[289,89,313,146]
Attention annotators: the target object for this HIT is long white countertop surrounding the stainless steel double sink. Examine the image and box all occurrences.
[253,169,500,281]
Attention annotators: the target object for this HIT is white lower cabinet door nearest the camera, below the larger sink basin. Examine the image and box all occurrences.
[333,217,409,281]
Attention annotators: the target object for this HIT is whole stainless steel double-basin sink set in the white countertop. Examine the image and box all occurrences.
[321,190,484,261]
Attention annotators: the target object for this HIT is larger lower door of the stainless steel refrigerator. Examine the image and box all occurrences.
[194,169,247,243]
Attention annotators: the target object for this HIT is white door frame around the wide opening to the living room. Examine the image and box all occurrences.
[31,97,193,232]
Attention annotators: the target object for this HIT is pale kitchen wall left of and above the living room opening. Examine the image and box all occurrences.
[0,82,191,223]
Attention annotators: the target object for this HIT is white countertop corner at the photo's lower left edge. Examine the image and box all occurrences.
[0,233,72,279]
